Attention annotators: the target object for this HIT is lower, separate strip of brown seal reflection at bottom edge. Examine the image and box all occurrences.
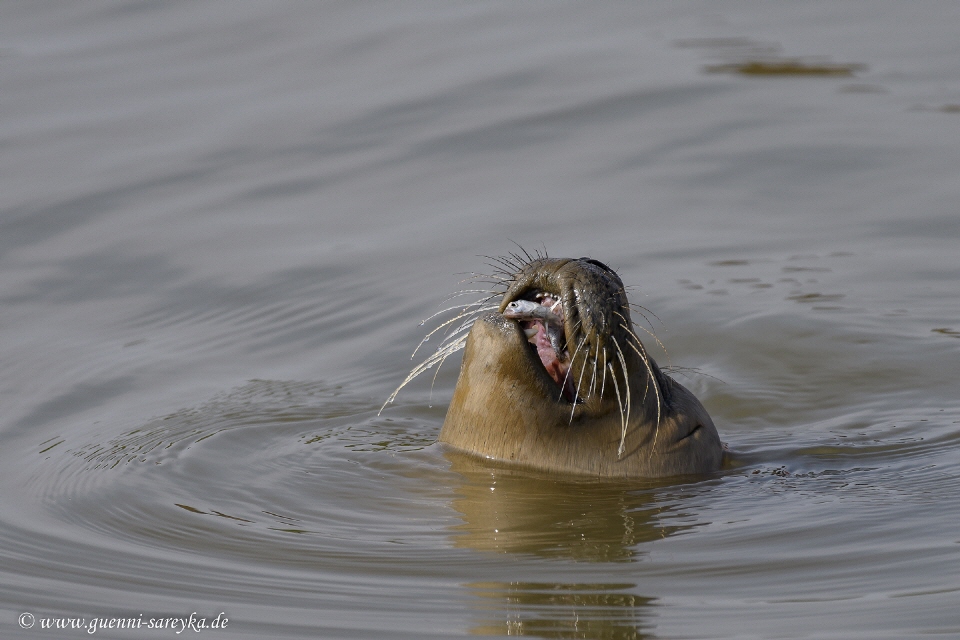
[467,582,654,639]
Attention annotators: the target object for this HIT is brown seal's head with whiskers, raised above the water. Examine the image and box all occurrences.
[388,253,723,478]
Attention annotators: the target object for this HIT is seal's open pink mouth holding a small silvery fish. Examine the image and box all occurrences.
[503,291,577,402]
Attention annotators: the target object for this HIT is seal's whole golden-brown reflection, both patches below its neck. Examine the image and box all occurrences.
[446,451,689,638]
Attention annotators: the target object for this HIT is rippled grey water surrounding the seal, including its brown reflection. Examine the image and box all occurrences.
[0,2,960,639]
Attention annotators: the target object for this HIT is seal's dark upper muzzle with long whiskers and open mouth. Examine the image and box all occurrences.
[381,252,640,420]
